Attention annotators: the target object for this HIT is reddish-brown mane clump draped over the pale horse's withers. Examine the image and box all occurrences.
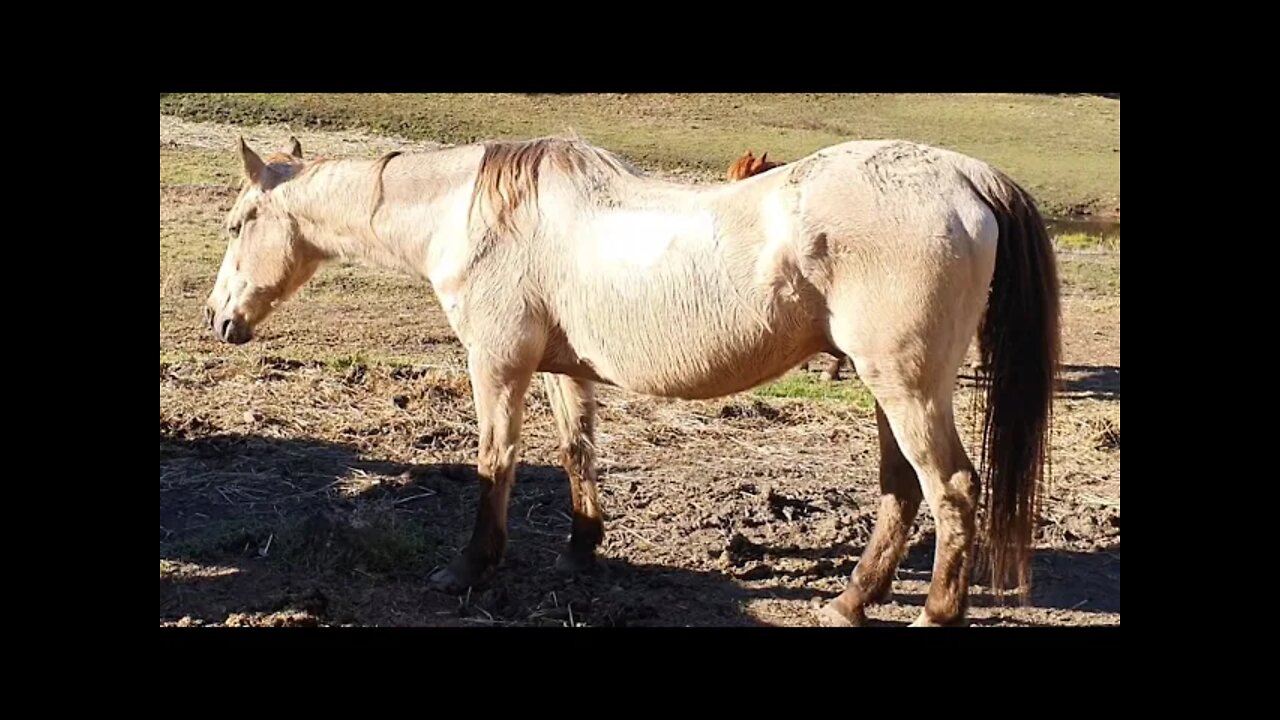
[468,137,640,240]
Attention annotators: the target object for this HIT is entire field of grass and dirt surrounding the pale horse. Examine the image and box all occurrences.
[160,95,1120,625]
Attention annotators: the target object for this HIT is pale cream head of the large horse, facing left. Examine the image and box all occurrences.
[205,138,323,345]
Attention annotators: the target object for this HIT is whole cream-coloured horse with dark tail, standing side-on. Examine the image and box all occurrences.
[205,137,1061,626]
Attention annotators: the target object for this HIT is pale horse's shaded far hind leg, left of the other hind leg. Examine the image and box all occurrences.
[822,404,922,626]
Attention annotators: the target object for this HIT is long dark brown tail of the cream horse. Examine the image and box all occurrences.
[972,170,1061,600]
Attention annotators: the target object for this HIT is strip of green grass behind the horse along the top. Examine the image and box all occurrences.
[160,94,1120,214]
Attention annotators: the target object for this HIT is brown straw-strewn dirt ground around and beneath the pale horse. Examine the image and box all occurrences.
[160,117,1120,625]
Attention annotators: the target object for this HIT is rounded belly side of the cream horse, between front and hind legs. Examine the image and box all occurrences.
[553,217,827,398]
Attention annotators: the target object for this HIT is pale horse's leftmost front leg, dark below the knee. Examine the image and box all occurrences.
[430,350,534,593]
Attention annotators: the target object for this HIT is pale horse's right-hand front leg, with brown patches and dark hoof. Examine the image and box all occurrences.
[543,373,604,571]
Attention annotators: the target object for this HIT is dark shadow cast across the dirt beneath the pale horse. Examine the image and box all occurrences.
[160,428,1119,626]
